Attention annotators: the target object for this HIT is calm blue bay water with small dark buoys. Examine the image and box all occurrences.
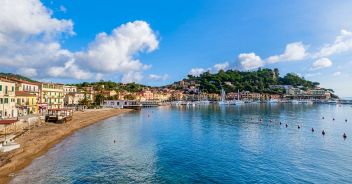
[12,104,352,184]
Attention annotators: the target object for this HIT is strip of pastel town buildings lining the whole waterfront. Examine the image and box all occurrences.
[0,69,346,120]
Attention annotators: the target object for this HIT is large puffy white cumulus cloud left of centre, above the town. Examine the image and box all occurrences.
[76,21,159,77]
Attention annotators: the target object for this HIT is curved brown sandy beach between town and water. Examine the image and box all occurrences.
[0,109,132,183]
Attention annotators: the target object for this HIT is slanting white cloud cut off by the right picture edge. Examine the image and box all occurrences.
[315,30,352,58]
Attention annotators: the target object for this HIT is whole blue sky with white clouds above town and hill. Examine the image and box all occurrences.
[0,0,352,97]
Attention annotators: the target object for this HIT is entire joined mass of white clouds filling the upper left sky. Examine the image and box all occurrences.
[0,0,159,81]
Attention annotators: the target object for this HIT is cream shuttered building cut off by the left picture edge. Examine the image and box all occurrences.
[0,78,17,119]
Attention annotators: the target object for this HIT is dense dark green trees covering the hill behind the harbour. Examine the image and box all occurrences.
[188,68,319,94]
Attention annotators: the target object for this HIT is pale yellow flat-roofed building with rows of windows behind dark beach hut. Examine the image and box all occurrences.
[39,83,64,110]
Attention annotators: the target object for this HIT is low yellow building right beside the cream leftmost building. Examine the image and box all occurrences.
[16,91,38,116]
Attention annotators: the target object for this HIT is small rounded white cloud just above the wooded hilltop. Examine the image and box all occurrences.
[238,52,264,70]
